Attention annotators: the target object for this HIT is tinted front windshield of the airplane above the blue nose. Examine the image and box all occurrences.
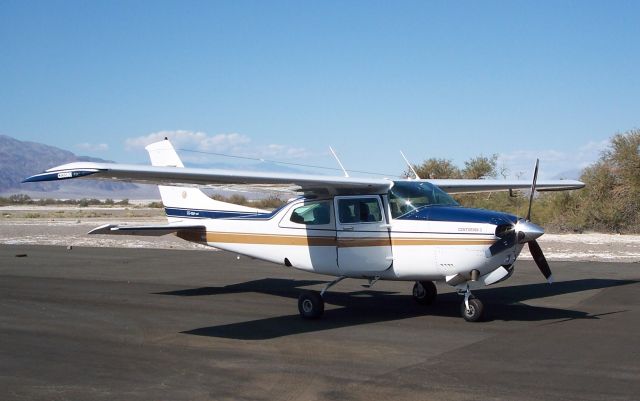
[389,181,459,218]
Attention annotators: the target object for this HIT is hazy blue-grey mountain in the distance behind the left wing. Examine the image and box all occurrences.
[0,135,160,199]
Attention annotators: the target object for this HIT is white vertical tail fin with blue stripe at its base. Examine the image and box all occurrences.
[146,139,264,223]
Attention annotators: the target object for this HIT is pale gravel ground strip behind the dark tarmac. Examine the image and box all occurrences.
[0,207,640,263]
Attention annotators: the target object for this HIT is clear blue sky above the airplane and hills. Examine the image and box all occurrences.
[0,0,640,178]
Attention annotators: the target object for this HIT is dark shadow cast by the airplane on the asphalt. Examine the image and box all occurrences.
[159,278,638,340]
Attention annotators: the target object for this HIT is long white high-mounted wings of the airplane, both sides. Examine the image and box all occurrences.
[23,162,584,195]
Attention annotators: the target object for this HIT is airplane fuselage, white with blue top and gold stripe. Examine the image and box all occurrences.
[167,185,522,282]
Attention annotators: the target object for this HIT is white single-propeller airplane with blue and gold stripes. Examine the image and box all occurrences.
[24,139,584,321]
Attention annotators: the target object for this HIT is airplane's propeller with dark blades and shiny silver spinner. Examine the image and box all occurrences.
[489,159,553,283]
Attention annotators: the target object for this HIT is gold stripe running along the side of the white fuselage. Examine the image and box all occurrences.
[206,231,495,248]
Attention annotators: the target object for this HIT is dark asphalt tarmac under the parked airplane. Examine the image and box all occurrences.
[0,245,640,401]
